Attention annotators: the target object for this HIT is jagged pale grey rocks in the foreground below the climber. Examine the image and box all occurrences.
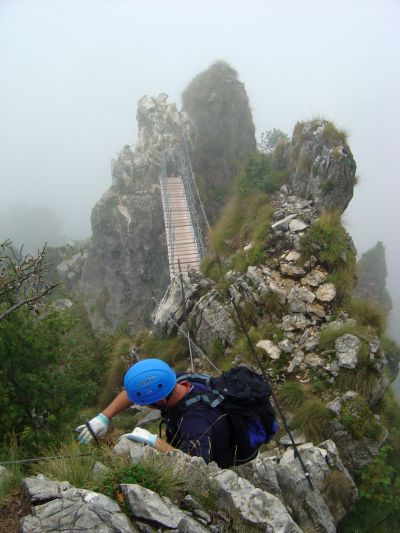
[21,439,358,533]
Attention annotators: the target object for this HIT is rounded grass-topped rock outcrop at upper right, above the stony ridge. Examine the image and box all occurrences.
[287,120,356,212]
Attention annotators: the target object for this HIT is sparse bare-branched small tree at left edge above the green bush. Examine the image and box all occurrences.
[0,239,58,321]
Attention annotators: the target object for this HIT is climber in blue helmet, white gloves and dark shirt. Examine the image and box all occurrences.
[76,359,235,468]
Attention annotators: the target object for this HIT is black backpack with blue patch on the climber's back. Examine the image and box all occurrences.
[177,366,278,464]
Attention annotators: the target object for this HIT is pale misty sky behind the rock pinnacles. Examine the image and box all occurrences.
[0,0,400,338]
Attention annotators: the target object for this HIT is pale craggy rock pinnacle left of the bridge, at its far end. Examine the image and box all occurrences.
[58,94,194,332]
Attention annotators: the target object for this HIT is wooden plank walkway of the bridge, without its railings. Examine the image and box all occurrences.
[163,176,200,279]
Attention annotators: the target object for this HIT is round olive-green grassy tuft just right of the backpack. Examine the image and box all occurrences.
[293,398,333,443]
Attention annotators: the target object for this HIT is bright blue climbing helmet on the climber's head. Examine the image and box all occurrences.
[124,359,176,405]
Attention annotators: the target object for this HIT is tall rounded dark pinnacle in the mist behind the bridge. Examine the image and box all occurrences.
[182,61,256,222]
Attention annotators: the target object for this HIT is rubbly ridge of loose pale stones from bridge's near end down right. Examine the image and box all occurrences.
[152,186,389,471]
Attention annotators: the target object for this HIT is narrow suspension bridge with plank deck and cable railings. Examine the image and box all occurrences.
[160,132,209,280]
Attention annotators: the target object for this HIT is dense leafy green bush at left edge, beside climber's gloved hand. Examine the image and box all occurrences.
[0,308,103,452]
